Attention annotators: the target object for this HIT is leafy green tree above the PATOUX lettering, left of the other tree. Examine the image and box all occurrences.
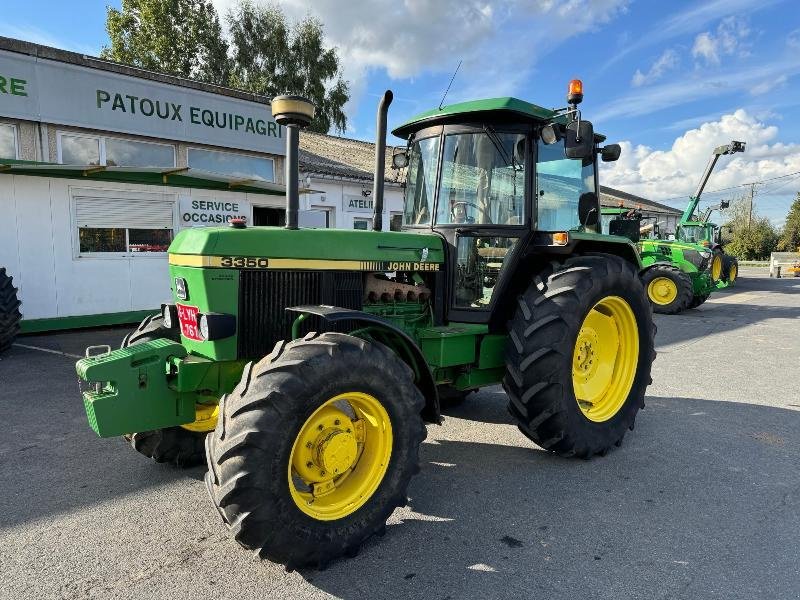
[100,0,230,85]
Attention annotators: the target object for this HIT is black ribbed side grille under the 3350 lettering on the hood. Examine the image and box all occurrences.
[238,270,363,358]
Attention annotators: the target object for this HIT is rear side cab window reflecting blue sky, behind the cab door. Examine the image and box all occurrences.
[536,140,597,231]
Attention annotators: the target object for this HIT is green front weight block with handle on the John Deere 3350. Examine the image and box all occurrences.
[75,339,196,437]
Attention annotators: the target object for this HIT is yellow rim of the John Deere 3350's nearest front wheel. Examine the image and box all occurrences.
[288,392,392,521]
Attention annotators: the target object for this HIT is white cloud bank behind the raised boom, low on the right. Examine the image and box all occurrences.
[601,109,800,205]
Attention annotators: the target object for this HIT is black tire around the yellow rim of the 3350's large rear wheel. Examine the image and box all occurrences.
[503,254,656,458]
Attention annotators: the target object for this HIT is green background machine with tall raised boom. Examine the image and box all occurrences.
[675,140,745,287]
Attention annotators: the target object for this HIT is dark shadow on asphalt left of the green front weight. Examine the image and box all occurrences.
[0,342,205,531]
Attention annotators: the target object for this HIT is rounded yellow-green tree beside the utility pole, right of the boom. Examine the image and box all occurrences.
[722,198,778,260]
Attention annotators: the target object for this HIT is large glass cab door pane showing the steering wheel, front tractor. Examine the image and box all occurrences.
[436,130,525,225]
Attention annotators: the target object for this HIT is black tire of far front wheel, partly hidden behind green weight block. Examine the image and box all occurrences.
[120,314,207,467]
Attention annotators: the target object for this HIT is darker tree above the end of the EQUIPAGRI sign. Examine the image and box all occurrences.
[227,0,350,133]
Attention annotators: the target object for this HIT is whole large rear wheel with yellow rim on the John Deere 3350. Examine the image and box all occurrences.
[503,255,655,458]
